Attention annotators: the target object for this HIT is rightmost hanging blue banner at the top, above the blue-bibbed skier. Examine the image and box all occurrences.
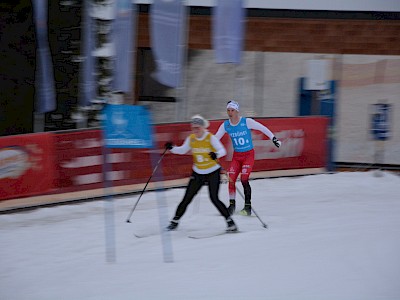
[212,0,246,64]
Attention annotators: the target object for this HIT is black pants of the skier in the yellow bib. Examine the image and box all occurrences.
[174,169,229,220]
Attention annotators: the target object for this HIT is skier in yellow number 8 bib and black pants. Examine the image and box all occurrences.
[165,115,238,232]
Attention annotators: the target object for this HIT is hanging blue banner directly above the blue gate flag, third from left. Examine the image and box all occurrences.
[113,0,136,93]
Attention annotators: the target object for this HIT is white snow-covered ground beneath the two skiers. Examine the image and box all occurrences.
[0,172,400,300]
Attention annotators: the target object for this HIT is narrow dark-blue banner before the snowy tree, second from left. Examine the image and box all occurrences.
[79,0,97,106]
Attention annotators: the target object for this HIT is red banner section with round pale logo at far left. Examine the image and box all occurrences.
[0,133,54,200]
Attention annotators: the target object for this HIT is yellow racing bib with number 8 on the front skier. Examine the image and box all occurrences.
[189,133,217,170]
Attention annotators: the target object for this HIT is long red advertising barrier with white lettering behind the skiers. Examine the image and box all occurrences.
[0,117,328,200]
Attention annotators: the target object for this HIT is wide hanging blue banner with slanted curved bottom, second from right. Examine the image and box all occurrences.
[150,0,186,88]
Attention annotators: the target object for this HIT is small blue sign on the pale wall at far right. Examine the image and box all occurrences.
[371,103,391,141]
